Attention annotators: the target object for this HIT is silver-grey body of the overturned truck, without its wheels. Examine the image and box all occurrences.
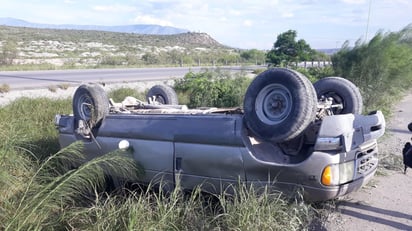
[55,108,385,201]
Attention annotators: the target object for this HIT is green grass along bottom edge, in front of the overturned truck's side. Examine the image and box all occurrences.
[60,185,315,230]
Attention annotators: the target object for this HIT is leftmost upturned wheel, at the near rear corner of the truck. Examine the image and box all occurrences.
[73,84,109,128]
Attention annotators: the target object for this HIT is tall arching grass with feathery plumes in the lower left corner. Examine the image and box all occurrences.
[3,143,142,230]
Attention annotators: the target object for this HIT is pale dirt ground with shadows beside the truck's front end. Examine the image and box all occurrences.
[314,92,412,231]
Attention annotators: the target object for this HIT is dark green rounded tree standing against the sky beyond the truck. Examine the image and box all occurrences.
[266,30,316,65]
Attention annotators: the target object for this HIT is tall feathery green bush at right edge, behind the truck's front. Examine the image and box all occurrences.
[332,27,412,114]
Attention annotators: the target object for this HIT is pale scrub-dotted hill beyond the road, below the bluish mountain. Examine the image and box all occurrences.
[0,26,233,68]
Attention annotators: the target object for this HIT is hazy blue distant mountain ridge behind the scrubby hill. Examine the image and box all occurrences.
[0,18,189,35]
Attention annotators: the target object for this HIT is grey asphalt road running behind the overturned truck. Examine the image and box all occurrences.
[0,66,257,90]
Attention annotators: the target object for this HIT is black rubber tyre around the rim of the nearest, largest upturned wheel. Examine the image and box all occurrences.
[244,68,317,143]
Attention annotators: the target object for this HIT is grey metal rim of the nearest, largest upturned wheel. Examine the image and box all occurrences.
[255,84,292,125]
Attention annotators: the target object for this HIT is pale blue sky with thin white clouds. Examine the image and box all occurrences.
[0,0,412,50]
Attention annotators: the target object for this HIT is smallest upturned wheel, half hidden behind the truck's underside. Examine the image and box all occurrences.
[146,84,179,105]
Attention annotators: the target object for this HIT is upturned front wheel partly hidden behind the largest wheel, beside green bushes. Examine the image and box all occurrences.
[314,77,363,115]
